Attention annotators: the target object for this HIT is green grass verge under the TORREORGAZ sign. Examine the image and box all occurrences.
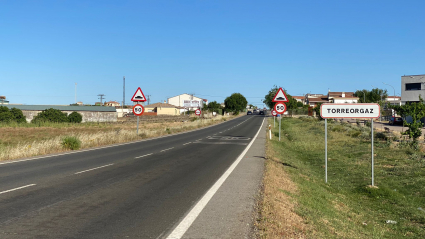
[271,118,425,238]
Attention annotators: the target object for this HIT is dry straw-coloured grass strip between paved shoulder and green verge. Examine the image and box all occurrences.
[253,143,308,238]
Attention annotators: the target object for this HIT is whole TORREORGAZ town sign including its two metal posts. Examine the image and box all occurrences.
[320,104,381,186]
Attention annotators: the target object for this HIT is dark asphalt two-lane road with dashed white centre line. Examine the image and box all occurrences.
[0,115,264,238]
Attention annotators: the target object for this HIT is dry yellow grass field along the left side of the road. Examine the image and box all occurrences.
[0,116,234,160]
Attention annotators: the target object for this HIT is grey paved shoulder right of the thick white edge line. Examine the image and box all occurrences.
[183,116,267,238]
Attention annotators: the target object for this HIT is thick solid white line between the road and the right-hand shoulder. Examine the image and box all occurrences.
[167,118,265,239]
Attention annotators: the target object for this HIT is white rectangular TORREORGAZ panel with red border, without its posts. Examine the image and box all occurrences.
[320,103,381,119]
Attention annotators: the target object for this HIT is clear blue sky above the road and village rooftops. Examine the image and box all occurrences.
[0,0,425,106]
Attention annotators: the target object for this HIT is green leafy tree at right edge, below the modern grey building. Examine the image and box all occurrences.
[389,96,425,143]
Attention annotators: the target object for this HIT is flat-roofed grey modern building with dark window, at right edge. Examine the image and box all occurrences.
[401,75,425,105]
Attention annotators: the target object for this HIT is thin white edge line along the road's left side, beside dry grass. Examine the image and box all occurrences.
[0,117,247,165]
